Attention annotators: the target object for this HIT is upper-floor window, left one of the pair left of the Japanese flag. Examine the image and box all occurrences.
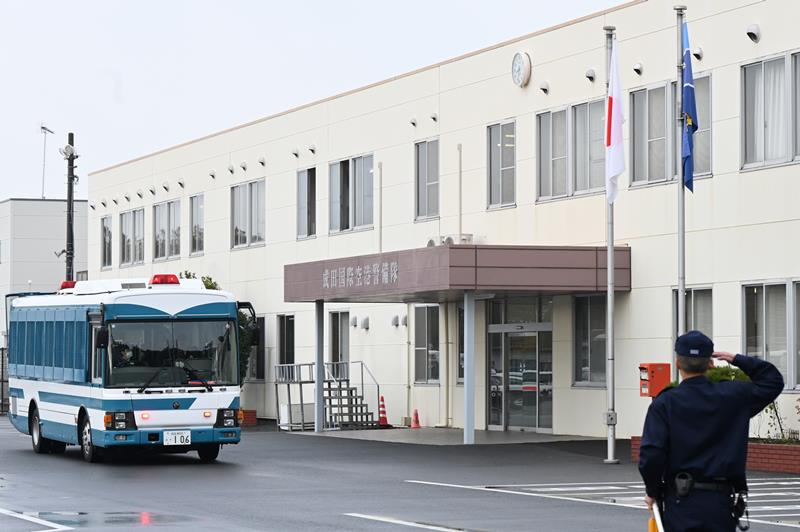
[537,111,567,198]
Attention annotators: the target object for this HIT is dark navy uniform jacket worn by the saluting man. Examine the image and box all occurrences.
[639,355,783,498]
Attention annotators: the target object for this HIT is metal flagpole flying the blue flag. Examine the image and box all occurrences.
[672,5,686,379]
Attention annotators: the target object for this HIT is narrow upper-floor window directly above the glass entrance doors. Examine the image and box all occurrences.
[487,122,517,207]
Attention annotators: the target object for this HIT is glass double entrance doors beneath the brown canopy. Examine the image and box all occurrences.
[487,300,553,432]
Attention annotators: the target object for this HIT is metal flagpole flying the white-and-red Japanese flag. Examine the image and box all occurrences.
[603,26,619,464]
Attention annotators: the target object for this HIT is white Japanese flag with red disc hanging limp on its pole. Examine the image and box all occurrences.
[605,39,625,204]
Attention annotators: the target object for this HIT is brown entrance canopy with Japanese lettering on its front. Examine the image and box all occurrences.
[283,245,631,303]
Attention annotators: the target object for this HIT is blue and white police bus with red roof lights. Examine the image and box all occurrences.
[7,274,252,462]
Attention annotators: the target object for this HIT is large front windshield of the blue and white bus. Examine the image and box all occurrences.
[105,320,238,388]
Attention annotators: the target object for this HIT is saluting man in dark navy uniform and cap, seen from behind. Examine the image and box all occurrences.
[639,331,783,532]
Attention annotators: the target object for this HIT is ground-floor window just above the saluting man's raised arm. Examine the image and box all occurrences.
[744,284,789,384]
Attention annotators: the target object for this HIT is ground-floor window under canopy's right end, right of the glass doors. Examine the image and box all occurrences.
[574,296,606,384]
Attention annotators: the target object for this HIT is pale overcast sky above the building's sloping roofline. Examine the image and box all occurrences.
[0,0,623,200]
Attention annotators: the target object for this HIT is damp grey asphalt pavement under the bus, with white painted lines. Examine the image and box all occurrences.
[0,417,800,532]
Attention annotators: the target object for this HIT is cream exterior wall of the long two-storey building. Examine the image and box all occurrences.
[88,0,800,436]
